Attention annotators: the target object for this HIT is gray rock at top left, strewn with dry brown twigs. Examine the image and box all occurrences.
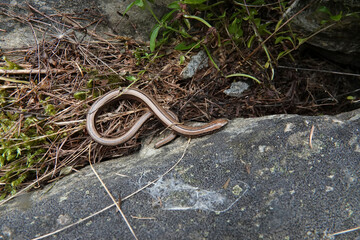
[0,0,171,49]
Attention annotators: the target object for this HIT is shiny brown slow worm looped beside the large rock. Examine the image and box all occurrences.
[86,88,228,147]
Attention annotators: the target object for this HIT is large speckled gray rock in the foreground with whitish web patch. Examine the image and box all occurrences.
[0,110,360,239]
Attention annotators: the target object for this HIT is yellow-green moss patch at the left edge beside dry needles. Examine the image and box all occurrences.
[0,112,52,199]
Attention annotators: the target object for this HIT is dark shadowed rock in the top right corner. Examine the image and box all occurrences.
[286,0,360,66]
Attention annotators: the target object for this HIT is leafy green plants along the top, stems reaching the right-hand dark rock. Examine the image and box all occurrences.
[126,0,357,82]
